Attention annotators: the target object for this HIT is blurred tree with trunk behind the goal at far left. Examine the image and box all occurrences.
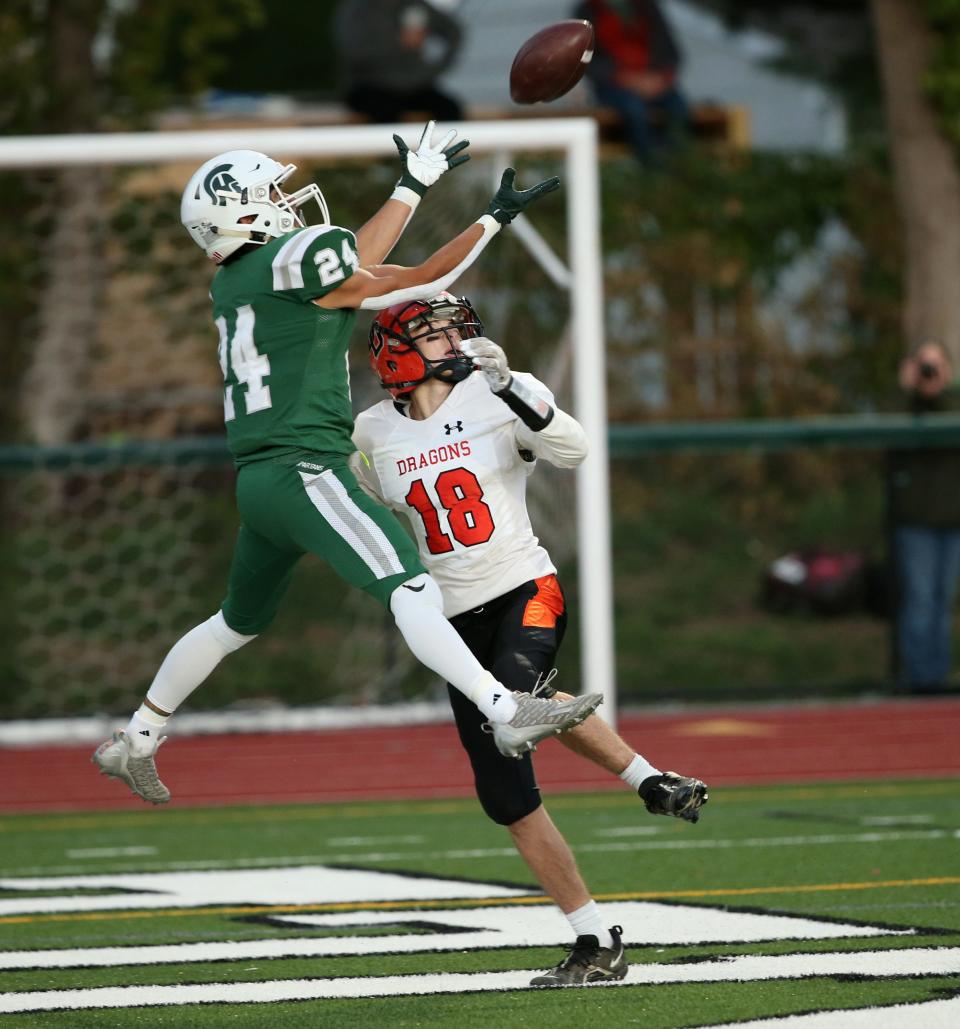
[0,0,261,445]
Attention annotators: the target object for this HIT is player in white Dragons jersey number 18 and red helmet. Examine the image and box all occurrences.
[351,293,708,986]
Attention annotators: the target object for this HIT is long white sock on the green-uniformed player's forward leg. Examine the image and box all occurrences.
[386,575,517,721]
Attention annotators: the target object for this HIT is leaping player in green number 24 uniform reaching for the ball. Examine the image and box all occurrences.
[93,122,602,804]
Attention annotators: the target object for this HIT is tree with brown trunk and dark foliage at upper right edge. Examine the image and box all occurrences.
[700,0,960,364]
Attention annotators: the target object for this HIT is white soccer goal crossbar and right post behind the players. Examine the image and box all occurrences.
[0,118,616,723]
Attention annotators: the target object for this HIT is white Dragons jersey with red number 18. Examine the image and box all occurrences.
[351,372,586,617]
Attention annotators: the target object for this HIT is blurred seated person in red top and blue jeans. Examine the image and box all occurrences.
[573,0,689,164]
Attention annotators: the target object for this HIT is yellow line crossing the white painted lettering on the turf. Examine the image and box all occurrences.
[0,876,960,925]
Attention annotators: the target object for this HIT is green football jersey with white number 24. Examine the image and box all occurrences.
[210,225,359,464]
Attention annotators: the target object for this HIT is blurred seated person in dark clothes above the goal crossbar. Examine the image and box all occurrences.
[334,0,463,121]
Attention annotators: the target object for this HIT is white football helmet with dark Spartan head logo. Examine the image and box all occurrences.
[180,150,330,264]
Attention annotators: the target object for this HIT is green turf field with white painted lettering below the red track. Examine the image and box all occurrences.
[0,781,960,1029]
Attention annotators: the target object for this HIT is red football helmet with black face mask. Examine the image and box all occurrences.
[369,293,484,400]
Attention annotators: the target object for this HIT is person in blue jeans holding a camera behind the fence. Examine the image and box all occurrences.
[889,341,960,693]
